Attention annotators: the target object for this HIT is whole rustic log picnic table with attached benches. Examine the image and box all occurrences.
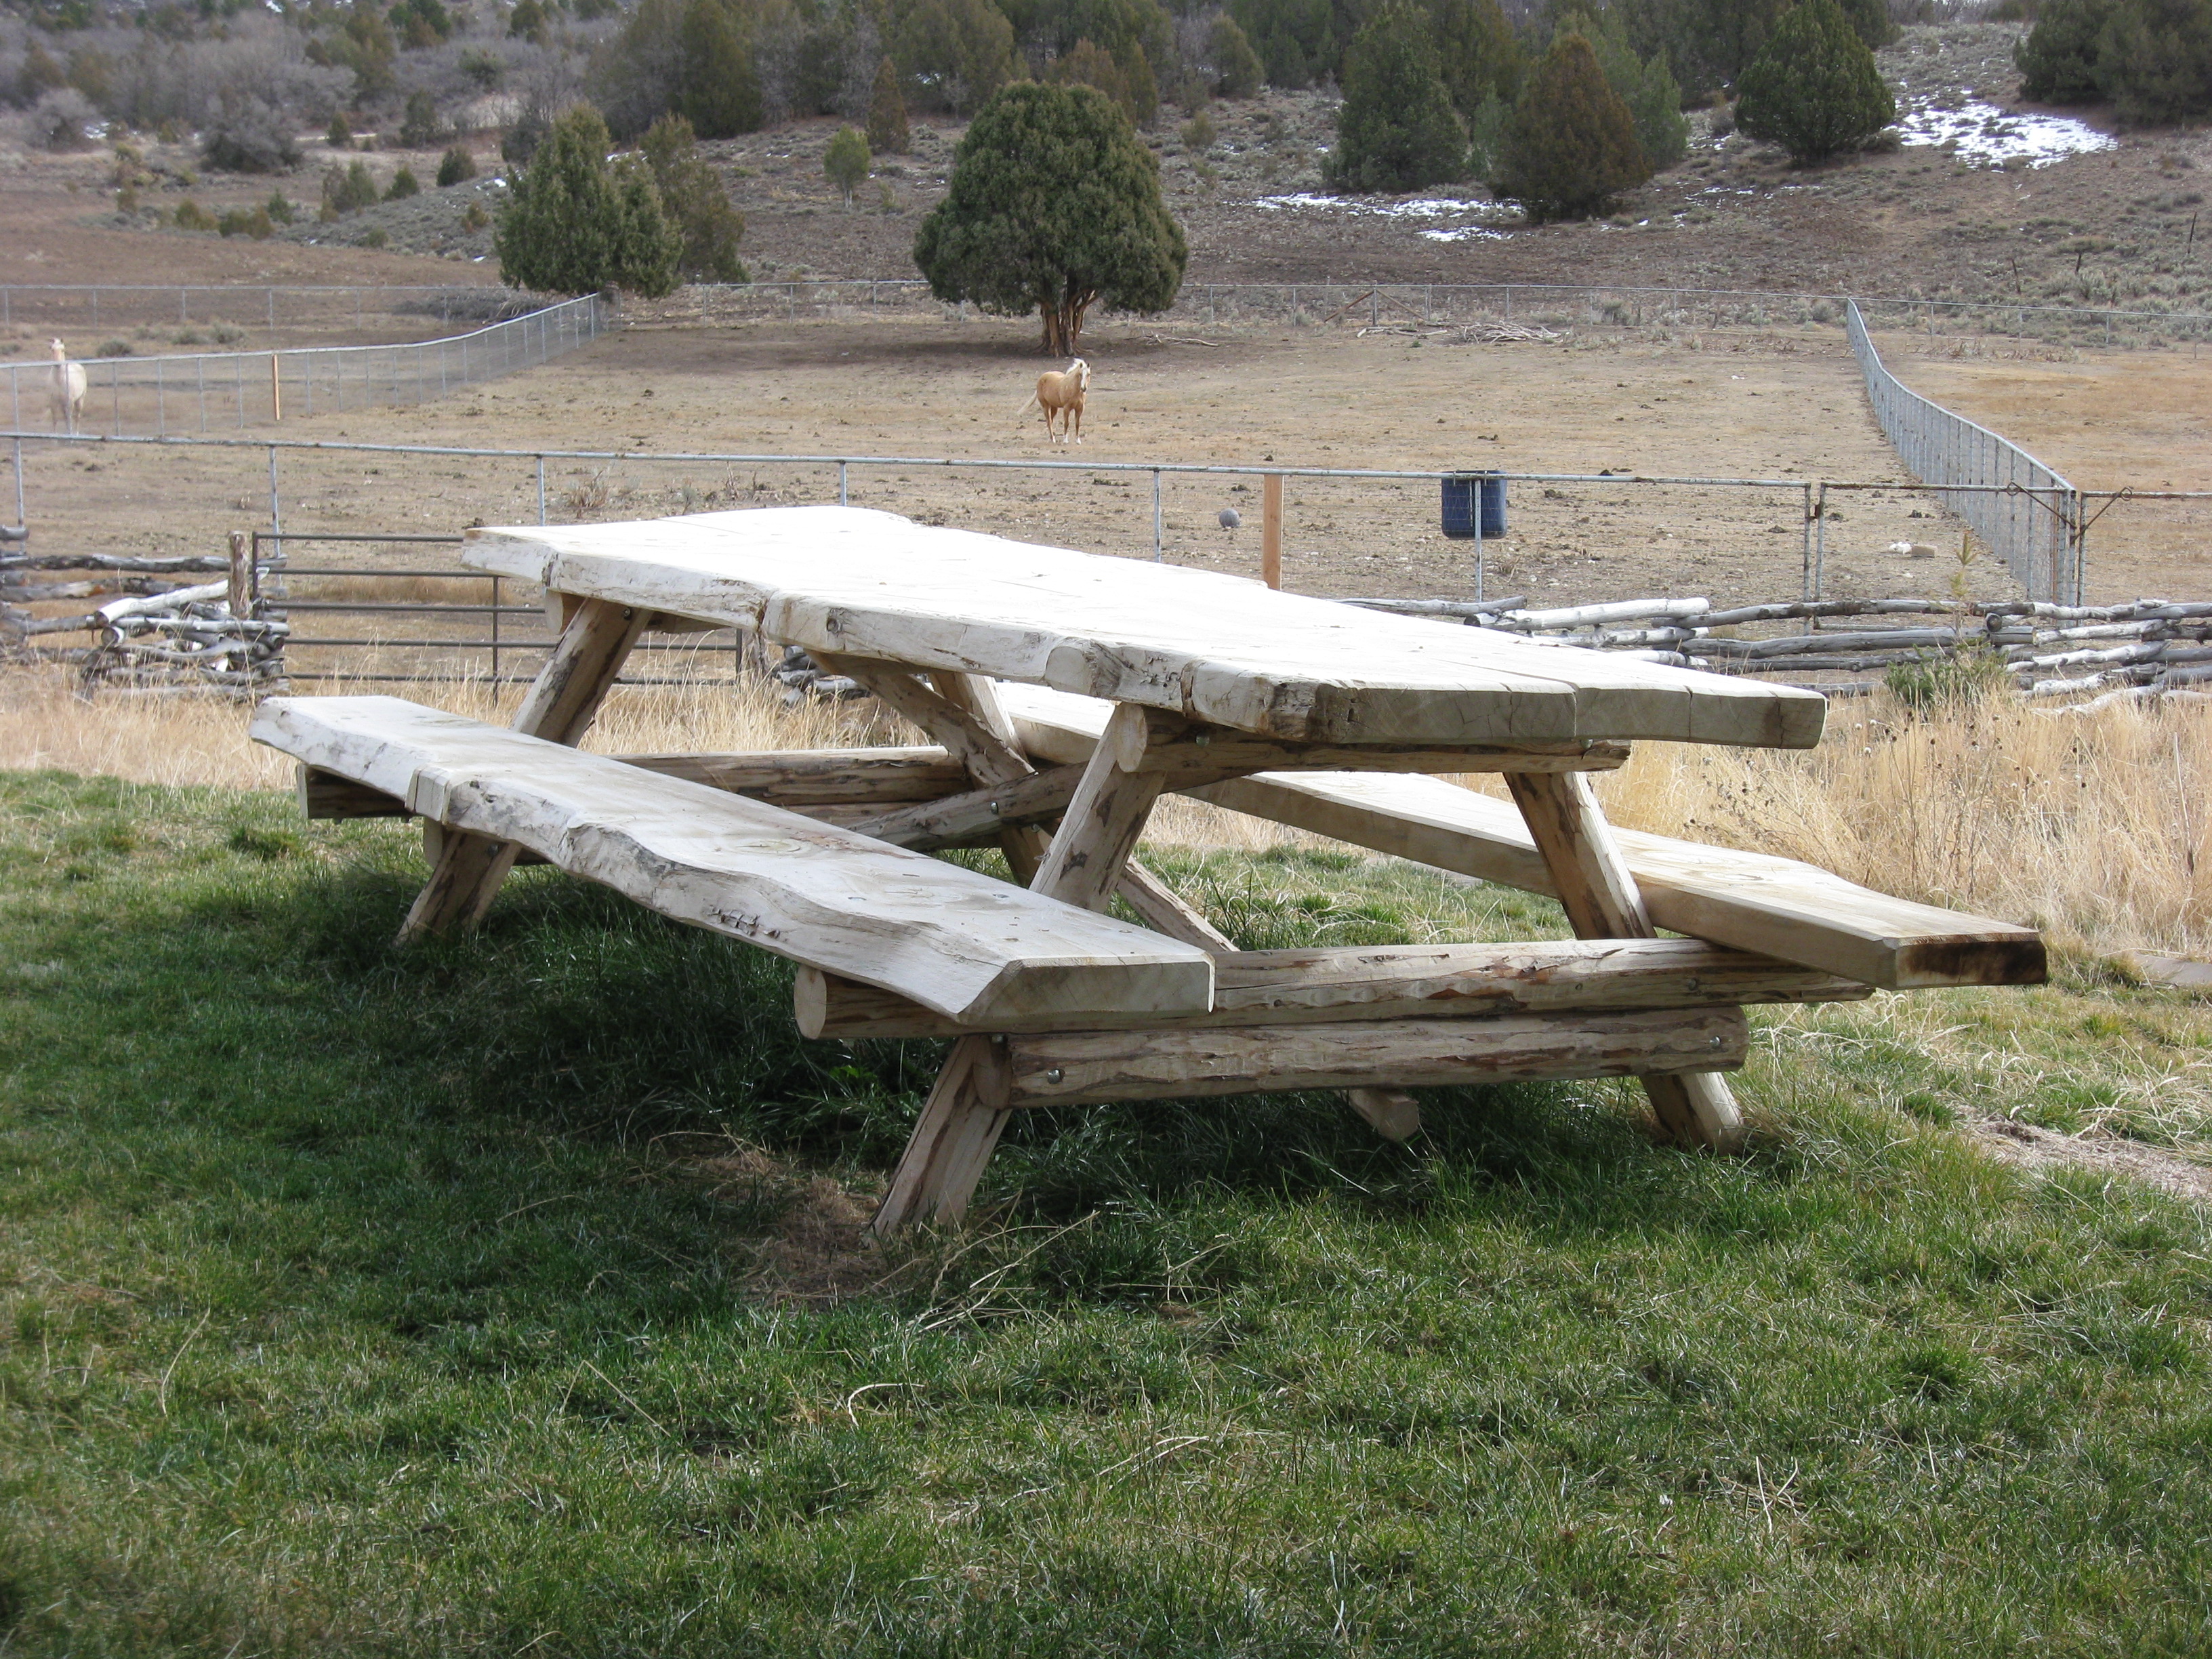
[254,506,2044,1230]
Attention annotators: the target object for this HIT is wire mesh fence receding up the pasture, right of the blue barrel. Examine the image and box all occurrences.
[1845,303,2084,604]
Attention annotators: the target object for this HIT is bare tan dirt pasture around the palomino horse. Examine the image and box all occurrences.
[26,309,2203,604]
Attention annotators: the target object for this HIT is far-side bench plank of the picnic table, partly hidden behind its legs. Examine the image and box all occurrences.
[1004,686,2046,991]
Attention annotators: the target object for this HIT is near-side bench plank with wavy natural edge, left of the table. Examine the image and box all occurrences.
[252,697,1212,1026]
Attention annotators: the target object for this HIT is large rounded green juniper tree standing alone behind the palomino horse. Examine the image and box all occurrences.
[914,82,1190,354]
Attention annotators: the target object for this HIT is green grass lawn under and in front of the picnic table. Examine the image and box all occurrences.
[0,774,2212,1659]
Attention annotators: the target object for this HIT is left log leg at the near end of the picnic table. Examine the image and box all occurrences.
[872,705,1166,1234]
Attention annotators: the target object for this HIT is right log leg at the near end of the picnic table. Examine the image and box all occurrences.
[1507,772,1743,1153]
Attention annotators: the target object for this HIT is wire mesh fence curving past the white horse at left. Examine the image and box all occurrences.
[5,290,613,438]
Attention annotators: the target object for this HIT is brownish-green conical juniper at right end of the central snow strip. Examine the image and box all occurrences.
[1491,33,1650,224]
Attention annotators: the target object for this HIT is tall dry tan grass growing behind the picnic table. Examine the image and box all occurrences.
[0,670,2212,956]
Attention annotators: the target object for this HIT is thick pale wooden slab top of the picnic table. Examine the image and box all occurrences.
[460,506,1827,747]
